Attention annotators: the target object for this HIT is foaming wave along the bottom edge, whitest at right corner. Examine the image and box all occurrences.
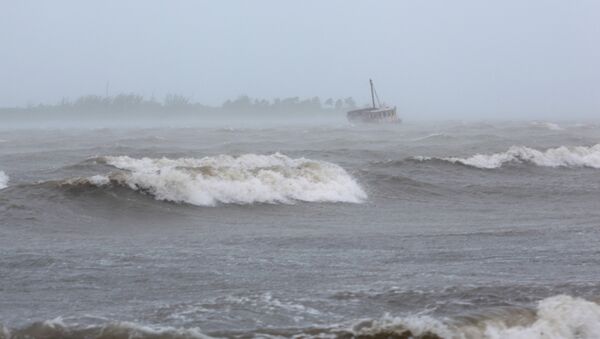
[0,295,600,339]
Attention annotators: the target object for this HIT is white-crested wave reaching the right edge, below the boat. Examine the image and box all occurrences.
[413,144,600,169]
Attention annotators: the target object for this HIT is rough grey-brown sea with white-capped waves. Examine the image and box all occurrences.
[0,121,600,339]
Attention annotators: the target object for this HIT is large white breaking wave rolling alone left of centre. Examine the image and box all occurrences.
[64,153,367,206]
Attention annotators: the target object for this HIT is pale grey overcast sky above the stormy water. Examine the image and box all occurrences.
[0,0,600,119]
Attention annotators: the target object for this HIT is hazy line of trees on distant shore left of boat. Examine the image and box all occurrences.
[0,94,356,118]
